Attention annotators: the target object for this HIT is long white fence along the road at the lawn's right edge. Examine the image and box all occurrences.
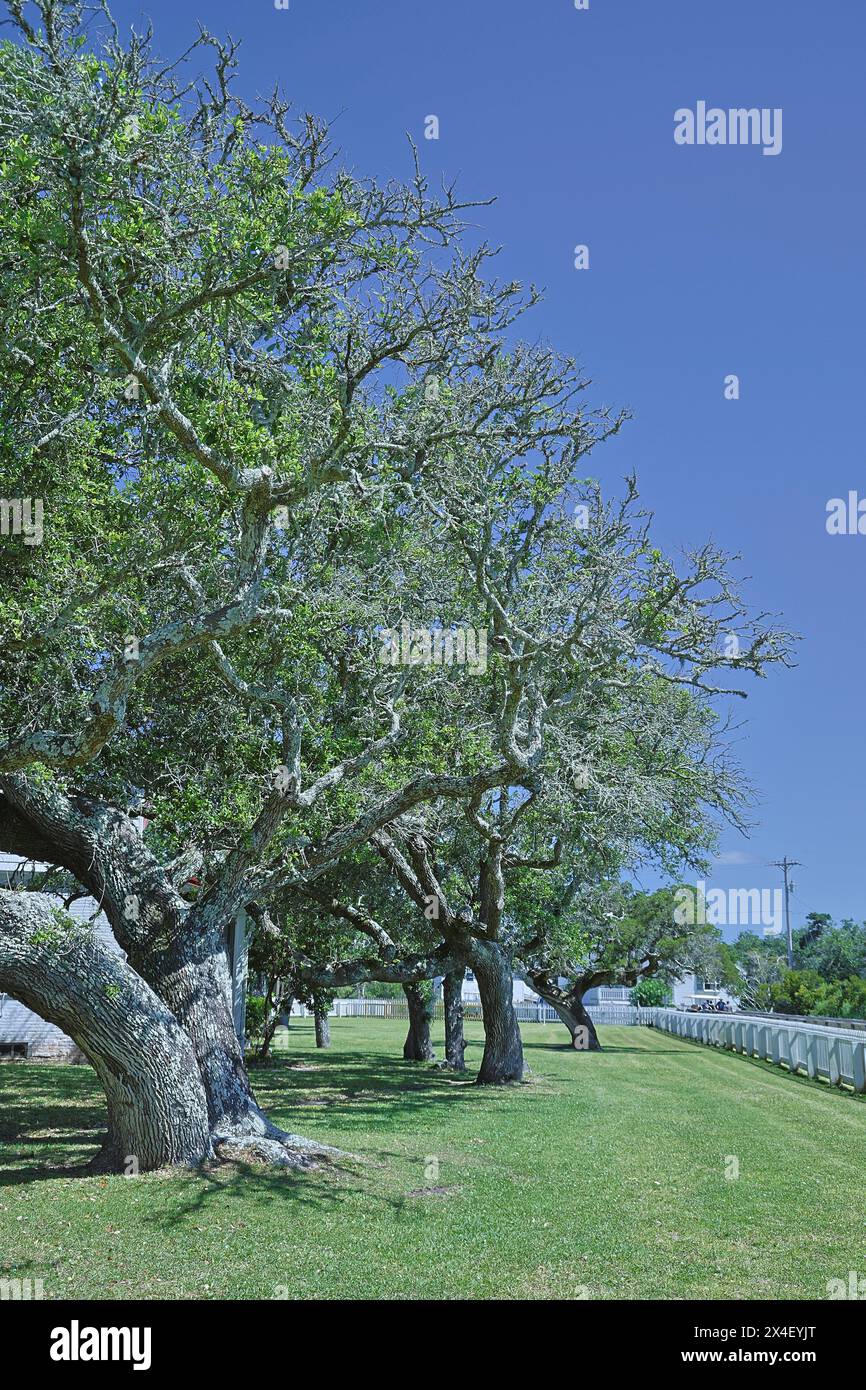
[641,1009,866,1093]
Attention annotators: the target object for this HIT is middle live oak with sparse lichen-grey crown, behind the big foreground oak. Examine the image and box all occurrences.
[255,478,787,1083]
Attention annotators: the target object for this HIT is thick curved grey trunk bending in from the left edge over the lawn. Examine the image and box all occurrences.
[0,891,211,1173]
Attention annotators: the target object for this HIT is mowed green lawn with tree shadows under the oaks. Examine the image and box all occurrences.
[0,1019,866,1300]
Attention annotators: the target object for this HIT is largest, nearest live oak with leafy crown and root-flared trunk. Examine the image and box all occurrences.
[0,0,619,1166]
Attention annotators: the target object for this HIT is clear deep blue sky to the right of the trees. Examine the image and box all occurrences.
[107,0,866,922]
